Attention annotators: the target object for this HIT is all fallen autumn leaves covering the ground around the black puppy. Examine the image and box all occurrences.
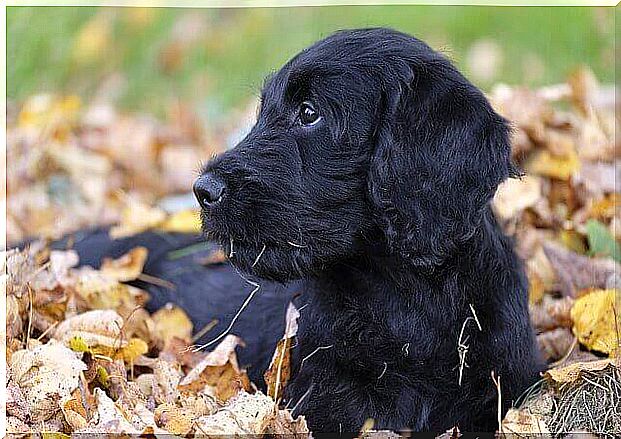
[3,66,621,436]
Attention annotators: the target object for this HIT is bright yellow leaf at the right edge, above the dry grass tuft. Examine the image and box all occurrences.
[571,289,621,354]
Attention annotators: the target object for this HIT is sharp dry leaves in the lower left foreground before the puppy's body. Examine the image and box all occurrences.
[4,246,308,435]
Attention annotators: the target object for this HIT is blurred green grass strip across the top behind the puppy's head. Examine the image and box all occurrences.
[7,6,614,118]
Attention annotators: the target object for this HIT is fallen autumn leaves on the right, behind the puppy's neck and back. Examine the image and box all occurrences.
[491,69,621,435]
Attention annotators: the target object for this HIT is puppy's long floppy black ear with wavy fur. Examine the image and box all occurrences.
[368,45,517,265]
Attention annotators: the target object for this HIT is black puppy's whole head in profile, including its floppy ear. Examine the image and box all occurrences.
[194,29,513,280]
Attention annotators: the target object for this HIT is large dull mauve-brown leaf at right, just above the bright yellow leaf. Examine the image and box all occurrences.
[543,242,621,297]
